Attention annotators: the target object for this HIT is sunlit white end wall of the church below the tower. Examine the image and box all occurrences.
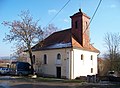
[72,49,98,79]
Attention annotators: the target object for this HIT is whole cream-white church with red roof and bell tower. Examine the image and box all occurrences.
[32,9,99,79]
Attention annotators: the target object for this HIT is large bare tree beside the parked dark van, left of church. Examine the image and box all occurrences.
[3,11,43,72]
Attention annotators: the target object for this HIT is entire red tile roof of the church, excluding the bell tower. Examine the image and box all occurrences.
[32,29,99,53]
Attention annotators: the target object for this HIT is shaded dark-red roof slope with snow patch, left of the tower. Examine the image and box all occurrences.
[32,29,71,50]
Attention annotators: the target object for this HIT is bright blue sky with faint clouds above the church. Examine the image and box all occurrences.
[0,0,120,56]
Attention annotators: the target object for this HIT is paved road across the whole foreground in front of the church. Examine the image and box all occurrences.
[0,76,120,88]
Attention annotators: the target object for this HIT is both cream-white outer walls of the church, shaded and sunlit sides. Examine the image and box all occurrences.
[27,48,98,79]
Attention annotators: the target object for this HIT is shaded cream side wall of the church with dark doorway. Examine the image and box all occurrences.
[33,48,71,78]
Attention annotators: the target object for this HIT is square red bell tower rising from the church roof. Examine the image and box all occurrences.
[70,9,90,47]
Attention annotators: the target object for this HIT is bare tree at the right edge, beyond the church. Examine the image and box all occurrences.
[104,33,120,70]
